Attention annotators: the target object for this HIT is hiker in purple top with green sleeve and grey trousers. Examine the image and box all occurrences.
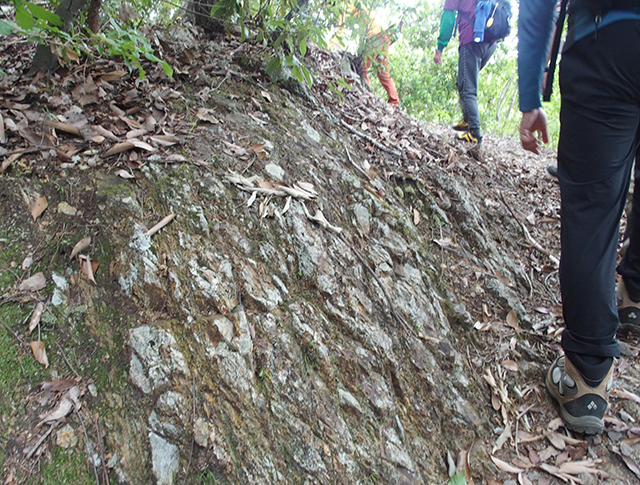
[433,0,496,144]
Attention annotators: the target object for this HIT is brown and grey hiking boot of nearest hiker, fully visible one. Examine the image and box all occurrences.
[545,355,613,434]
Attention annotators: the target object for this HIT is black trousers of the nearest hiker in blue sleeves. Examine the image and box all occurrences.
[558,21,640,357]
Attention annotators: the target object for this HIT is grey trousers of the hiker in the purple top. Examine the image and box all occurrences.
[456,42,496,136]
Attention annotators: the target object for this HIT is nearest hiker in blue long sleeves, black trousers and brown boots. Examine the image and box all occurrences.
[518,0,640,434]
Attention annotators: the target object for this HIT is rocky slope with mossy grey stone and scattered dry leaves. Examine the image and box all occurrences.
[0,20,640,484]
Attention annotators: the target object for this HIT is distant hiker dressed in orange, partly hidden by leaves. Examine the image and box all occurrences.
[329,4,400,108]
